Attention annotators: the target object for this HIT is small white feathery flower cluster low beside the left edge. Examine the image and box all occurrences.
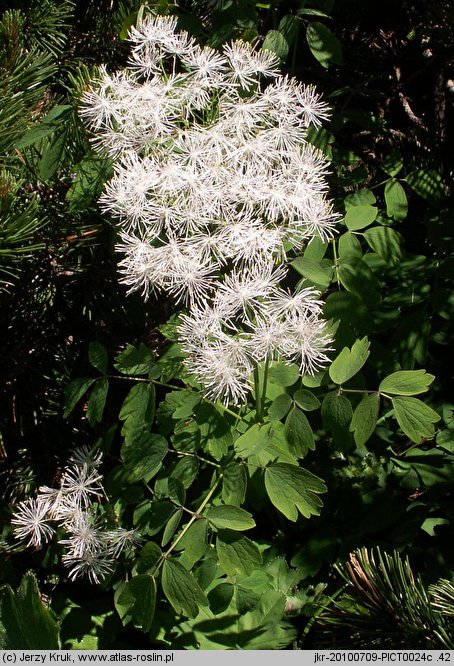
[11,447,138,583]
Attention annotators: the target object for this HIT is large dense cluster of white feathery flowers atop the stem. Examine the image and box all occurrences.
[81,16,337,403]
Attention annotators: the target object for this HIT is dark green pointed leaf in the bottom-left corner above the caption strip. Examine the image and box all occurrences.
[0,573,60,650]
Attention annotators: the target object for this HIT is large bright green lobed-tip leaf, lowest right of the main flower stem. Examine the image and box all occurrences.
[265,463,327,522]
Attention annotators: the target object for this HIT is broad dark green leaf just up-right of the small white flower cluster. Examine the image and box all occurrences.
[121,430,168,483]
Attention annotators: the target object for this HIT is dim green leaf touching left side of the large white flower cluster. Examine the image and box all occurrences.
[66,153,112,212]
